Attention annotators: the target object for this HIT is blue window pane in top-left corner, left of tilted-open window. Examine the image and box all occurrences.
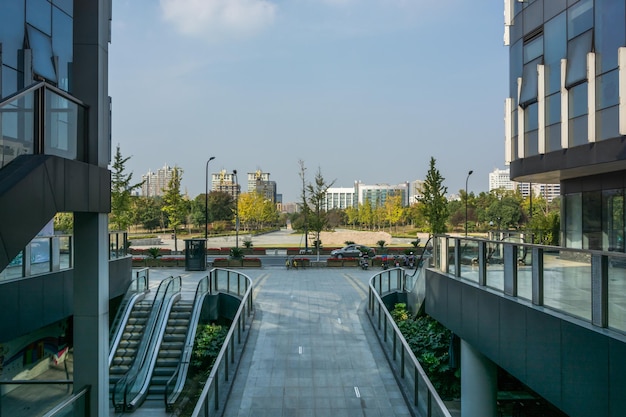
[0,0,24,68]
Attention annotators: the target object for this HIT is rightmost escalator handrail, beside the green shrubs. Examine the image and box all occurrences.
[163,271,213,410]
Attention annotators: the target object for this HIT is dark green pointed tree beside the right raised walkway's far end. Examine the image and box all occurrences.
[420,156,448,235]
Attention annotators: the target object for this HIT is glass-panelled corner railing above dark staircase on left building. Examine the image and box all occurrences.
[0,82,85,168]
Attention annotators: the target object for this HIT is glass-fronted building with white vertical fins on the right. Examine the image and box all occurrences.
[504,0,626,252]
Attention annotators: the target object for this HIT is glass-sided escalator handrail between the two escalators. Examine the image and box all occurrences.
[111,276,181,411]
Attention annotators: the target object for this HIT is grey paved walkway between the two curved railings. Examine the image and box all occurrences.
[224,268,410,417]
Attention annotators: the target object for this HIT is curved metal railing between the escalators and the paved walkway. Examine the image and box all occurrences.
[192,269,254,417]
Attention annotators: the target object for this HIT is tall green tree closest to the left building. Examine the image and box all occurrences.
[109,145,143,230]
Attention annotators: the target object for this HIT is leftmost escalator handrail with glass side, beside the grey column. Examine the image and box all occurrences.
[109,268,150,366]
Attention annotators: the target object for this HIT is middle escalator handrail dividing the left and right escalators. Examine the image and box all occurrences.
[111,276,181,409]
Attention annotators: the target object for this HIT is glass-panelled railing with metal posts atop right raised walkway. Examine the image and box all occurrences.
[433,236,626,333]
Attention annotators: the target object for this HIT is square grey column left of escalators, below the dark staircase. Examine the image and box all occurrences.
[74,213,109,416]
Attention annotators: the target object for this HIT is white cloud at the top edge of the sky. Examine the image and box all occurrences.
[160,0,276,38]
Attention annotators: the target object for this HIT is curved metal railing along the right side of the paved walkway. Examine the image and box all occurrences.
[367,268,451,417]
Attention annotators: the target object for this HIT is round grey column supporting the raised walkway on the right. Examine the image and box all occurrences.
[461,339,498,417]
